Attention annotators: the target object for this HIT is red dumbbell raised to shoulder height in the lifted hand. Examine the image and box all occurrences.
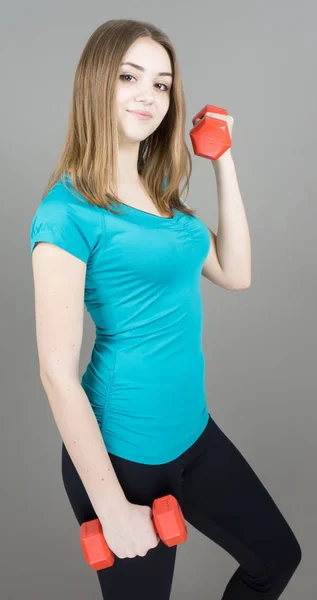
[189,104,231,160]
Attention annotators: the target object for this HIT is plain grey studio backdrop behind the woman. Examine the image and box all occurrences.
[0,0,317,600]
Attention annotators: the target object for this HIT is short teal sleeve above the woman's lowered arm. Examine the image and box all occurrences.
[30,184,101,263]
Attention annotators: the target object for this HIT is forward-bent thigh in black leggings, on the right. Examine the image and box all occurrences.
[181,419,301,575]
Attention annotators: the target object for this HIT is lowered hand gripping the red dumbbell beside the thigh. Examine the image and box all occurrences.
[99,501,160,558]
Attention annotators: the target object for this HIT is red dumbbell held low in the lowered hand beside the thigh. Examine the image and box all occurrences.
[80,494,187,571]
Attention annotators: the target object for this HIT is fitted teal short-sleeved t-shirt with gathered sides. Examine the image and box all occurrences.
[30,173,210,465]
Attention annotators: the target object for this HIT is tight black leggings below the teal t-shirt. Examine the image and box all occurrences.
[62,415,302,600]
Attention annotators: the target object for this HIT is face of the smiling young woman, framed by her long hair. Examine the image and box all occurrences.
[116,38,172,142]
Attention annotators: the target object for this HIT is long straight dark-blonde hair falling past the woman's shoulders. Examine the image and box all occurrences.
[42,19,196,215]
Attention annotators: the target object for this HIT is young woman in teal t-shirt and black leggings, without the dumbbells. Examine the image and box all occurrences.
[30,19,301,600]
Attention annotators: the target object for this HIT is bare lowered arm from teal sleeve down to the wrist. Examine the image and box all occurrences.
[32,242,128,519]
